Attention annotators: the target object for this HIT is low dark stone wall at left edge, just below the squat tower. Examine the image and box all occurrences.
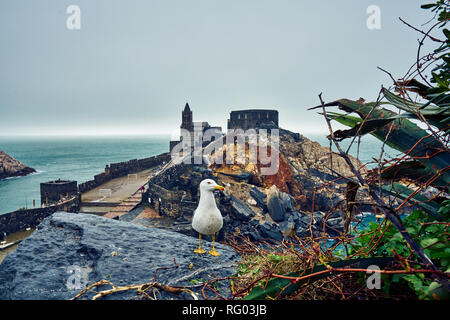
[0,194,81,240]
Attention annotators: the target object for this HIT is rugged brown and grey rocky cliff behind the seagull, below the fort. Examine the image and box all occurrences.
[128,129,368,241]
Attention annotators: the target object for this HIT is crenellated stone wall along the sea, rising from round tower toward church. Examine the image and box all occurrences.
[78,152,170,193]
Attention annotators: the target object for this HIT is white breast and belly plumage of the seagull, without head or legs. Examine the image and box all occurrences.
[192,192,223,234]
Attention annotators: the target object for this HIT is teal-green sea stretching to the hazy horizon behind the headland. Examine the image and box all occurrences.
[0,134,398,214]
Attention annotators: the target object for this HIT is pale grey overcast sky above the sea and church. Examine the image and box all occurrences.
[0,0,438,135]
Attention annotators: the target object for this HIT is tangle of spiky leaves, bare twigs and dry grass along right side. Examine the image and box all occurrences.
[216,0,450,300]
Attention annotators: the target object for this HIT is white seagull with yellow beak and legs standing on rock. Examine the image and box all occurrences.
[192,179,224,257]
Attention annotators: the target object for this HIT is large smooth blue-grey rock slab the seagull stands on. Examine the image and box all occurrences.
[0,212,239,299]
